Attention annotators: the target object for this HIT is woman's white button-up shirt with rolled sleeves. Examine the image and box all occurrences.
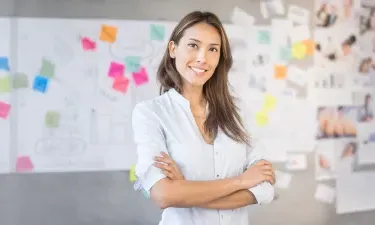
[132,89,274,225]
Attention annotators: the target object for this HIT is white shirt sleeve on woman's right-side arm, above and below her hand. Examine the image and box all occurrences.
[246,138,275,204]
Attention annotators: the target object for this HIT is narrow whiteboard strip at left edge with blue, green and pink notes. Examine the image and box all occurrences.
[0,18,11,173]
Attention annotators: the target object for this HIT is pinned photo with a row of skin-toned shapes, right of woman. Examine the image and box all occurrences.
[316,106,357,139]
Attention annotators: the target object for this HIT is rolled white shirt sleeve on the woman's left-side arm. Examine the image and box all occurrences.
[132,103,167,196]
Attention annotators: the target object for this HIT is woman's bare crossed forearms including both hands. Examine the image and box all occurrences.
[151,153,274,209]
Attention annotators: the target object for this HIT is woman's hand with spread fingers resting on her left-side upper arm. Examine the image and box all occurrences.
[154,152,185,180]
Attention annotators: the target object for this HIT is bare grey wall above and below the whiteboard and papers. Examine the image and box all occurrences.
[0,0,375,225]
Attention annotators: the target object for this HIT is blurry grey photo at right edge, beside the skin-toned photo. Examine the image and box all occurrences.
[353,92,374,123]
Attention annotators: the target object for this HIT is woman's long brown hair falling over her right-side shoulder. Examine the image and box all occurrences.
[157,11,250,145]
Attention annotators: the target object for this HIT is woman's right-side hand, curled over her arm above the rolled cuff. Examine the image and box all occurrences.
[240,160,275,189]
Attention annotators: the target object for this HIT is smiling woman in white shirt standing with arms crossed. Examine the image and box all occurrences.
[133,11,275,225]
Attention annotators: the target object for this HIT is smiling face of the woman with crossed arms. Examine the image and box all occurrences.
[169,23,221,87]
